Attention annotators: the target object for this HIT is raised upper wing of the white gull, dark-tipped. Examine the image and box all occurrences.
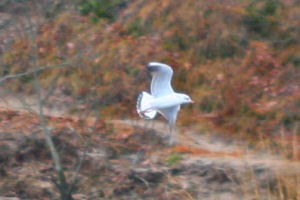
[148,62,174,97]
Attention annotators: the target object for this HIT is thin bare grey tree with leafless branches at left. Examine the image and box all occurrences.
[0,1,84,200]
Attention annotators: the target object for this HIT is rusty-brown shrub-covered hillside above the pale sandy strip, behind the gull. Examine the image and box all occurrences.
[0,0,300,137]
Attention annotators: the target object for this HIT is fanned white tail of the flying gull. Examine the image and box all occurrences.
[136,92,157,119]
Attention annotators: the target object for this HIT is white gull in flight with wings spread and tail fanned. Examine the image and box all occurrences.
[136,62,194,145]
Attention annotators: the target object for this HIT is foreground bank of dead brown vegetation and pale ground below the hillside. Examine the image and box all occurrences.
[0,108,300,199]
